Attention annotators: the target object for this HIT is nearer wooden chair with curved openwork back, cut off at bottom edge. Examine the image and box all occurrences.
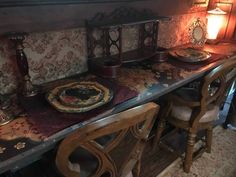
[56,103,159,177]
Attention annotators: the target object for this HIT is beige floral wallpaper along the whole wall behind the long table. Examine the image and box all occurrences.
[0,12,205,93]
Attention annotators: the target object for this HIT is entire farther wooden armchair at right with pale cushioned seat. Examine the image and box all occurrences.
[154,59,236,172]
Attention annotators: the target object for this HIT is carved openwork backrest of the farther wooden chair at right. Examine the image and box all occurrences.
[192,59,236,126]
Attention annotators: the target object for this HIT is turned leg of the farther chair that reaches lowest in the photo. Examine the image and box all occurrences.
[184,132,196,173]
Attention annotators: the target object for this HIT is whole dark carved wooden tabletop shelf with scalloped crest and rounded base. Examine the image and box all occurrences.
[86,7,168,78]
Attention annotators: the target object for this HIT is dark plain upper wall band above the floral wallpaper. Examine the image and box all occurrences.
[0,0,206,36]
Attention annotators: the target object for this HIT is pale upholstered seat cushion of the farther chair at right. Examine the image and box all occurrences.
[171,105,219,123]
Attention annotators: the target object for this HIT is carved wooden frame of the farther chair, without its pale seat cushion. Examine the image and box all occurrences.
[154,59,236,172]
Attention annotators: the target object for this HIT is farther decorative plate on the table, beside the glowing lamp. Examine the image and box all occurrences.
[169,48,211,63]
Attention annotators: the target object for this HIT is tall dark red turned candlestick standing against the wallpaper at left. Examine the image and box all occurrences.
[9,33,39,97]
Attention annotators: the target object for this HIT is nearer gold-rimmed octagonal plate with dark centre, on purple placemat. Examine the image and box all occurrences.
[46,82,113,113]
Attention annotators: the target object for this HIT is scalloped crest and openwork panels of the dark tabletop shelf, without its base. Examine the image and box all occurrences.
[86,7,158,59]
